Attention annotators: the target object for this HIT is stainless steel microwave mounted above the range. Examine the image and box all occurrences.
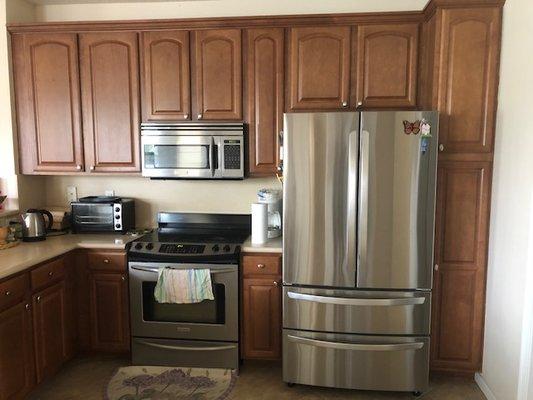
[141,122,244,179]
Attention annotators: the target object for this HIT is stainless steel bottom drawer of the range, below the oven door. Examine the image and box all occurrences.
[131,337,239,369]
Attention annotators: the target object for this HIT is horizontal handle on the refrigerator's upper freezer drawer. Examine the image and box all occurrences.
[287,292,426,306]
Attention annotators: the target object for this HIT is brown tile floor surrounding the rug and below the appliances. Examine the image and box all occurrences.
[30,357,485,400]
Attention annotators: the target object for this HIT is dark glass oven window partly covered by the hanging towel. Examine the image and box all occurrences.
[142,282,226,325]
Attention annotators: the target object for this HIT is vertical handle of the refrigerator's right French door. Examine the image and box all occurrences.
[357,130,370,273]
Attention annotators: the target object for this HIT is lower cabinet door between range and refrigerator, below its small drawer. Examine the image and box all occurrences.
[243,276,281,359]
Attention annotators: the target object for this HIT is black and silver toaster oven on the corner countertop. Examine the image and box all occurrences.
[71,196,135,233]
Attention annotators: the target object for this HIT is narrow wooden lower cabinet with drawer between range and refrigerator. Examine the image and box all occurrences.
[241,254,281,360]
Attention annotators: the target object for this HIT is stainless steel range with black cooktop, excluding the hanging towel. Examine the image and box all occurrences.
[128,213,250,369]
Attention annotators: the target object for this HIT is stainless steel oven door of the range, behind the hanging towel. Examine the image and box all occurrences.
[129,262,239,341]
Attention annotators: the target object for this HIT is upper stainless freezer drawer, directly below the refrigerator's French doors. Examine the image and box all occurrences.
[283,286,431,335]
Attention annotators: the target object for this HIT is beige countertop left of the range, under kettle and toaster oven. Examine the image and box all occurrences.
[0,234,138,279]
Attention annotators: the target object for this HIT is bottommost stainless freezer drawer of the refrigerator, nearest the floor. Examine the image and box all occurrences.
[283,329,429,392]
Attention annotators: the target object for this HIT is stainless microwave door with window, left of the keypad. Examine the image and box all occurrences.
[141,134,218,179]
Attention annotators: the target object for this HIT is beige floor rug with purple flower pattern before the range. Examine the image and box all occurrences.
[106,366,236,400]
